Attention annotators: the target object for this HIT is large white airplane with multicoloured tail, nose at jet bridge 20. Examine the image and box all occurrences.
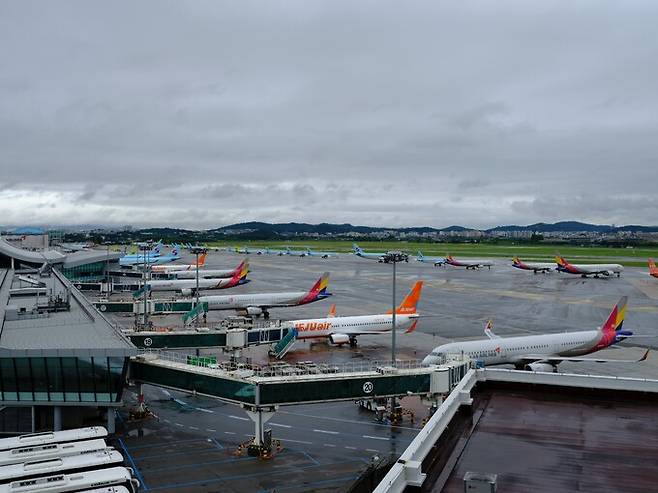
[423,296,649,372]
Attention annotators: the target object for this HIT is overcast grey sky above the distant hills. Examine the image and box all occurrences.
[0,0,658,228]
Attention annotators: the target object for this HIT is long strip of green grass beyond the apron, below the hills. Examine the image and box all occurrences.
[200,240,658,267]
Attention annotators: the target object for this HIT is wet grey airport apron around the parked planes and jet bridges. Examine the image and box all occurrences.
[105,252,658,492]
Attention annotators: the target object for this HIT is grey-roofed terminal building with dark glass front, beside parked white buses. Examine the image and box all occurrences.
[0,266,137,432]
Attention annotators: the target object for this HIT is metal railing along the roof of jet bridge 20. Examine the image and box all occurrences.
[136,349,468,378]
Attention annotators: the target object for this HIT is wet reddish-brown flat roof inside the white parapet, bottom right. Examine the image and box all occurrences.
[438,390,658,493]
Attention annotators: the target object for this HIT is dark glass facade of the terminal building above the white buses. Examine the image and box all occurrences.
[0,357,128,403]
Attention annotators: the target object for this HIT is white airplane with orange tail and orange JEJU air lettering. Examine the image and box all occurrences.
[290,281,423,347]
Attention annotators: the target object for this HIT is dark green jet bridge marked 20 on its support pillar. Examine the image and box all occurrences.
[128,350,472,455]
